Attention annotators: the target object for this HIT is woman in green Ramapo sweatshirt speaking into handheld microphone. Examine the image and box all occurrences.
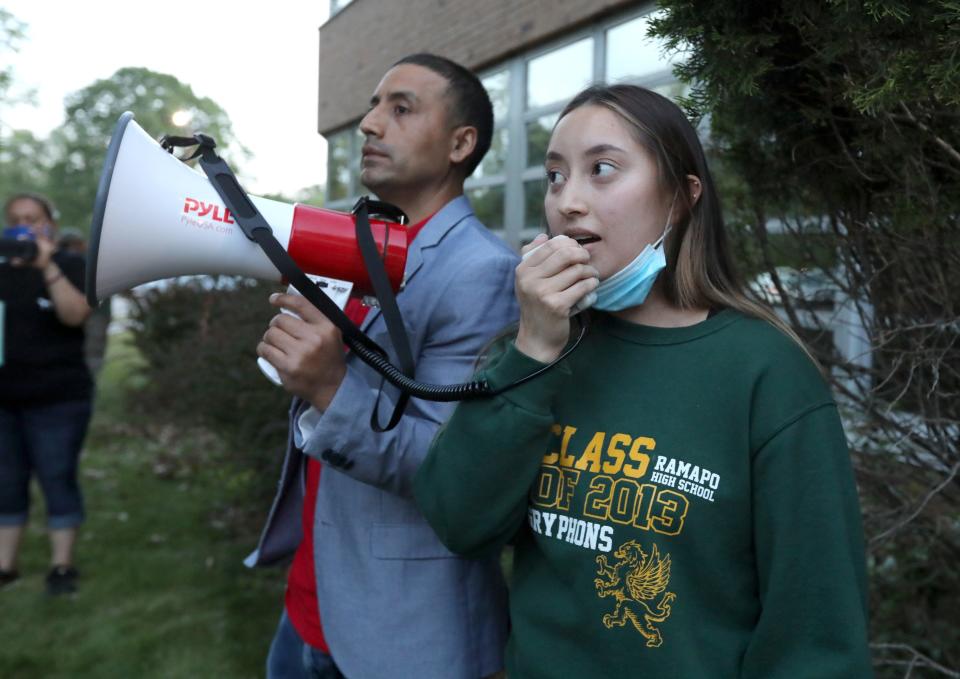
[416,85,871,679]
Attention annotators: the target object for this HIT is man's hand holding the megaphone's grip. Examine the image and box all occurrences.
[257,293,347,410]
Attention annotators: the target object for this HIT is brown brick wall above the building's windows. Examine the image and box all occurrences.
[313,0,651,134]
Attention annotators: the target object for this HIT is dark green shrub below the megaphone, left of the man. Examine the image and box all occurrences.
[130,277,290,512]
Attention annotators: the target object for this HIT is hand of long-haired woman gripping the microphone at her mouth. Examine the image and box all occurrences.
[516,234,600,363]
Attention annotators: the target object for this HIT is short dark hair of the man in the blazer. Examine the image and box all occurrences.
[393,52,493,178]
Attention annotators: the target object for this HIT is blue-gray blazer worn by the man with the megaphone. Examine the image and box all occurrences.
[247,196,518,679]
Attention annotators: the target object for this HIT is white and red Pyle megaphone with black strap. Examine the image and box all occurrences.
[86,112,407,306]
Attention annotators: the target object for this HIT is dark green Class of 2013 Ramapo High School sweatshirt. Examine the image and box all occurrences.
[415,311,873,679]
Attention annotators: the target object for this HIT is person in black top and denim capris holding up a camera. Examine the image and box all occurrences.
[0,193,93,594]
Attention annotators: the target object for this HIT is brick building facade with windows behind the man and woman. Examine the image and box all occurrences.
[318,0,682,248]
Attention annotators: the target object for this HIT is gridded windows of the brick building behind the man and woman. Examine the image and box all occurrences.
[327,9,684,248]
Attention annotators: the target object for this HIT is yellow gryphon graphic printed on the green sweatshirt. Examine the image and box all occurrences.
[593,540,677,648]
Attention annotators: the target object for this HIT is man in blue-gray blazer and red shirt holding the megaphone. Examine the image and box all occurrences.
[250,54,518,679]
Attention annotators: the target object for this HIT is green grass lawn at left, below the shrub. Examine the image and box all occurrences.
[0,336,285,679]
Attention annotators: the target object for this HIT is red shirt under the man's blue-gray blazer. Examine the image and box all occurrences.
[284,215,433,653]
